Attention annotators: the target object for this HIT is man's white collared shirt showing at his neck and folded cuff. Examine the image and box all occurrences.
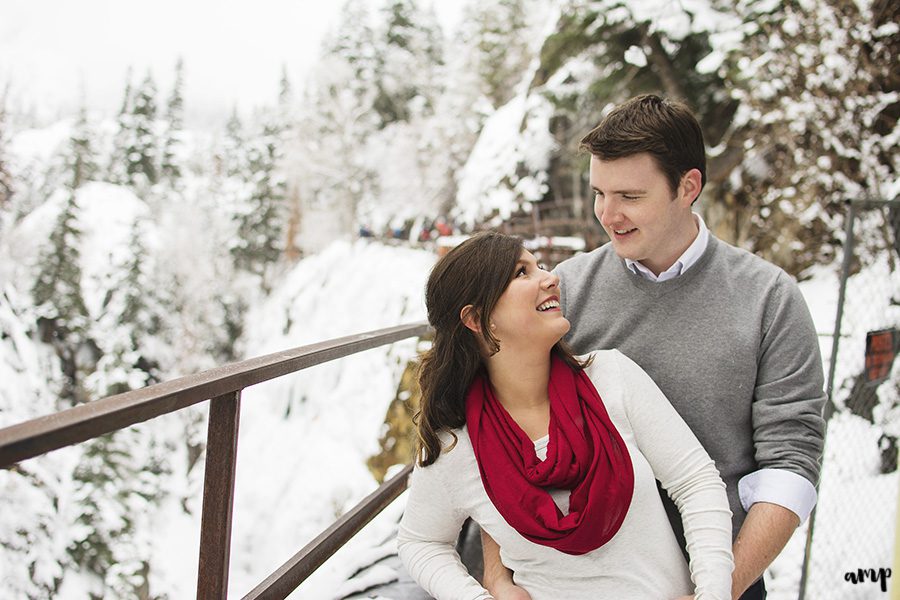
[625,213,818,523]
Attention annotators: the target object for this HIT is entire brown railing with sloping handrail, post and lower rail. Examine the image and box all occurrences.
[0,323,428,600]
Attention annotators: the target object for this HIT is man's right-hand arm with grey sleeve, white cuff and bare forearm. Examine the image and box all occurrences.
[732,273,825,598]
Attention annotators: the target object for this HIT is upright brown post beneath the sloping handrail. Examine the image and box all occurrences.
[197,390,241,600]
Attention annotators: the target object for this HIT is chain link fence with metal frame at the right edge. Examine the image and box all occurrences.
[799,200,900,600]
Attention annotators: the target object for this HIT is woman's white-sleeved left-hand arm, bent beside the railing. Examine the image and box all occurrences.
[397,459,492,600]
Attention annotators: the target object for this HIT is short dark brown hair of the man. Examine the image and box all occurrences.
[581,94,706,193]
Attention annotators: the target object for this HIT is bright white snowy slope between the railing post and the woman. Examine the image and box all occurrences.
[203,241,435,598]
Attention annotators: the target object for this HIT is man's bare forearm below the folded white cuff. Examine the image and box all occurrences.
[736,502,800,600]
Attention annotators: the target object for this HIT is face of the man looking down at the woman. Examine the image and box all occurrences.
[591,153,699,275]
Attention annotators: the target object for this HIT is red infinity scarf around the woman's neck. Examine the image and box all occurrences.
[466,355,634,555]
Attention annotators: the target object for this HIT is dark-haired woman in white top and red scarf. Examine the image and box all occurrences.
[398,233,733,600]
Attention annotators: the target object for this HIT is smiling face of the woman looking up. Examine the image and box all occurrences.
[490,250,569,350]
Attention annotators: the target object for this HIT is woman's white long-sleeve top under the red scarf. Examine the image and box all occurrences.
[397,350,734,600]
